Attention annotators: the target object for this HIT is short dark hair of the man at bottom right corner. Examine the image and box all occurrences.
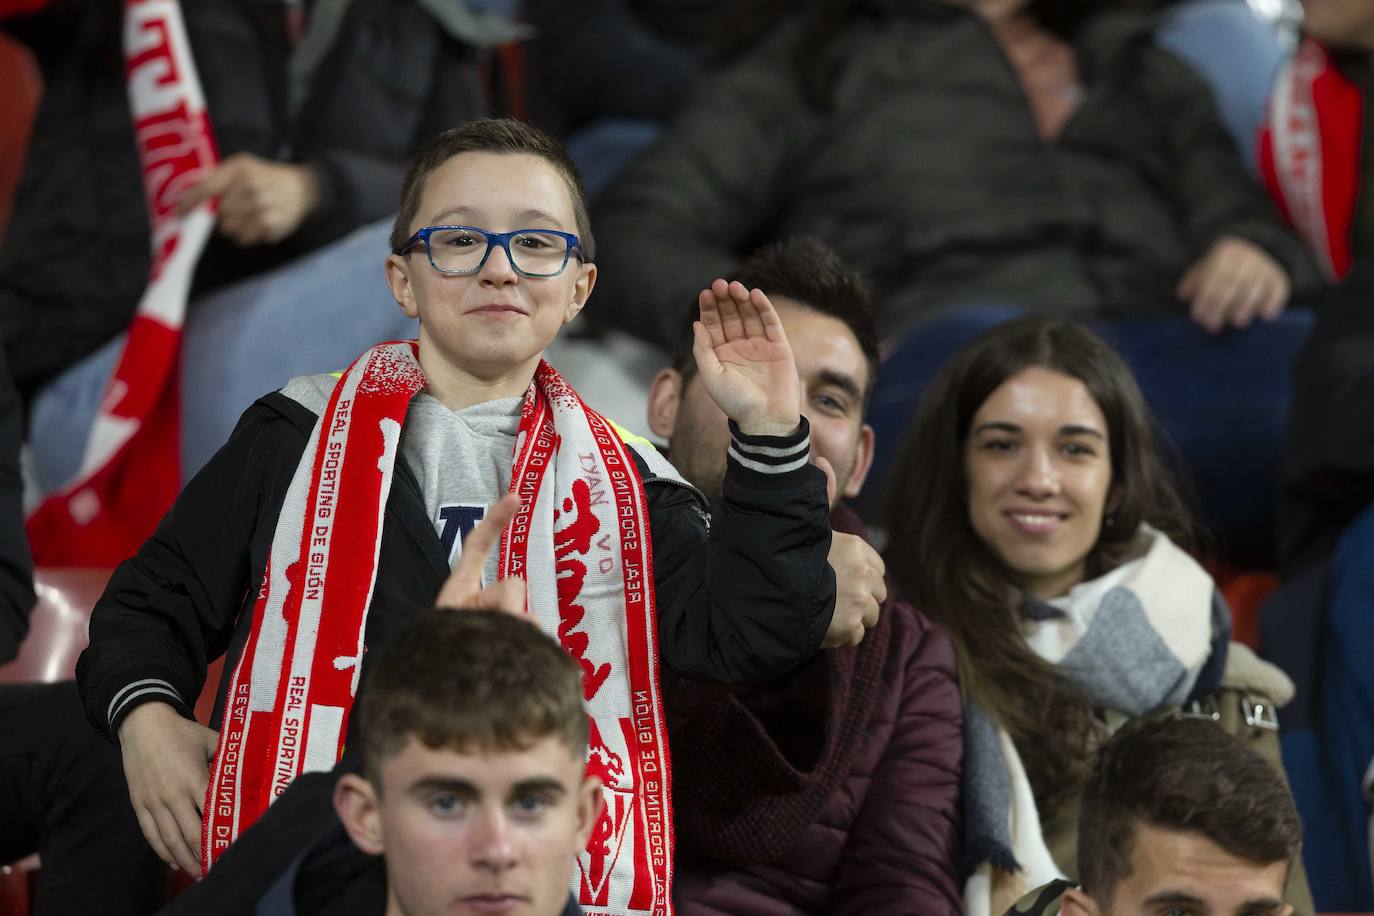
[1079,715,1303,909]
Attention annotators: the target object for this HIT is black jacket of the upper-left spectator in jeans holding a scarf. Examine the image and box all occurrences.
[0,0,486,394]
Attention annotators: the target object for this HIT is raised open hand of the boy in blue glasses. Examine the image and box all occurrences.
[692,280,801,435]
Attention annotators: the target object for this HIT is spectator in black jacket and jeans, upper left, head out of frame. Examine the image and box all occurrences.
[0,0,523,502]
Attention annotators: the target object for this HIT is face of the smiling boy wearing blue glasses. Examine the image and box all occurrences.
[386,152,596,382]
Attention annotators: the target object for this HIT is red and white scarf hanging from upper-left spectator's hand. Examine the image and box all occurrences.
[27,0,218,566]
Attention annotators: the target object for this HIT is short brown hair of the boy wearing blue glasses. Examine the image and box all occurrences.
[392,118,596,261]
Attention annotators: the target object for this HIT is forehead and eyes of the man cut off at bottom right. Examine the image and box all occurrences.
[1062,824,1293,916]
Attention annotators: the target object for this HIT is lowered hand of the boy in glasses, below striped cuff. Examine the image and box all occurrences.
[120,702,220,875]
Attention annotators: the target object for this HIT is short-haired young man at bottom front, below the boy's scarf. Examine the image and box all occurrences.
[257,608,602,916]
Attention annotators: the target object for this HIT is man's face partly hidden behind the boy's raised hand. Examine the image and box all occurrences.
[649,299,872,503]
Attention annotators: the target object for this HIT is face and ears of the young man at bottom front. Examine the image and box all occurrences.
[334,736,600,916]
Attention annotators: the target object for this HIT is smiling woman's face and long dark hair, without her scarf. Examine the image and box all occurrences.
[888,316,1209,808]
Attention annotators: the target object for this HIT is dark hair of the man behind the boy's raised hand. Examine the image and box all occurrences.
[672,238,878,407]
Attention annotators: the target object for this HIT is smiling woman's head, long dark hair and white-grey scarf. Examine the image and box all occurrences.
[885,316,1308,913]
